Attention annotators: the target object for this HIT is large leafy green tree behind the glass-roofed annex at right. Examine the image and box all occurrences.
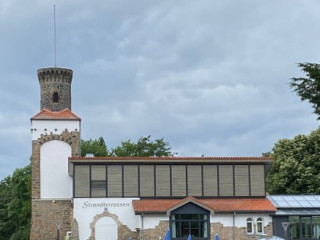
[267,128,320,194]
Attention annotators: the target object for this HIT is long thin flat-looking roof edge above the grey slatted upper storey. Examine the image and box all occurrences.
[69,157,273,163]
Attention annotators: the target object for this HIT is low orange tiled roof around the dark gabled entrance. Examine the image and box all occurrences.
[132,197,276,214]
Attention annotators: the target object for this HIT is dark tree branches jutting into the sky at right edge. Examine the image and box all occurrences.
[290,63,320,120]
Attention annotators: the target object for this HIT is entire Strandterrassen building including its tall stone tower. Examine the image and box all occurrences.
[30,68,276,240]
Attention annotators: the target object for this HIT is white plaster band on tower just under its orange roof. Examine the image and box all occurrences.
[31,120,80,140]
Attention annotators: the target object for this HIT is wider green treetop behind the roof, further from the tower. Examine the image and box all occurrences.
[110,135,174,157]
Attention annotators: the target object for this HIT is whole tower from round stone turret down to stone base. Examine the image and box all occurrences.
[30,67,81,240]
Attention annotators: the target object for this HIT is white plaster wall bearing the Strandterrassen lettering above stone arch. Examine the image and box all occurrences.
[74,198,140,240]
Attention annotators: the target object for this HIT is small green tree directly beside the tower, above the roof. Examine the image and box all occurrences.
[81,137,109,157]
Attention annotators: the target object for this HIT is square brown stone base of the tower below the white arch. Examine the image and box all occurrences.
[30,199,73,240]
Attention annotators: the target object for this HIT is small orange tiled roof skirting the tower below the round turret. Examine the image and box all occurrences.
[31,108,81,120]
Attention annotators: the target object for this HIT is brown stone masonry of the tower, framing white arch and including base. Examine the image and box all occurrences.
[30,131,80,240]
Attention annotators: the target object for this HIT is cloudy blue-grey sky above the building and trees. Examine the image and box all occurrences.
[0,0,320,179]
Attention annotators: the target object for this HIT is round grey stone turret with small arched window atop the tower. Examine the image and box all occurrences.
[38,68,72,111]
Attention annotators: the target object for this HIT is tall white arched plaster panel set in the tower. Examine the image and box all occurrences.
[40,140,72,199]
